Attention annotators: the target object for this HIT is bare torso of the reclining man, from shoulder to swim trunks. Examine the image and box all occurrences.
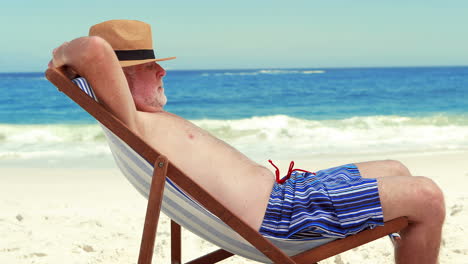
[138,112,274,230]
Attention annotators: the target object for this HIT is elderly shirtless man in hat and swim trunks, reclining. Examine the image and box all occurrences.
[49,20,445,263]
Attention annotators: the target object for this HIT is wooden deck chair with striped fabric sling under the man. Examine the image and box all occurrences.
[46,68,408,264]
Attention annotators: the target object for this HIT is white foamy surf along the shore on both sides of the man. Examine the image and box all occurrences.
[0,115,468,164]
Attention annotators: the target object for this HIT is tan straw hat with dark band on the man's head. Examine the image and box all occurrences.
[89,20,175,67]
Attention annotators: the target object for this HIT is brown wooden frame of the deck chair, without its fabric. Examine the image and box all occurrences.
[46,68,408,264]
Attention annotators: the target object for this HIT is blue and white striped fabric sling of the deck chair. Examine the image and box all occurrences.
[74,78,344,263]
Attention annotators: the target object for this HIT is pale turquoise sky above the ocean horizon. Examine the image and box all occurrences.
[0,0,468,72]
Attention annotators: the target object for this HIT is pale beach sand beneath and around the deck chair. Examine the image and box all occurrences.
[0,151,468,264]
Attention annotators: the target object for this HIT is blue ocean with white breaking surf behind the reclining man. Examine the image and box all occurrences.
[0,67,468,167]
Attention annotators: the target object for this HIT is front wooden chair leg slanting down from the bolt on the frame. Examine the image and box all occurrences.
[138,156,168,264]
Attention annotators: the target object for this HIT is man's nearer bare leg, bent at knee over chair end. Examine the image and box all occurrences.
[377,176,445,263]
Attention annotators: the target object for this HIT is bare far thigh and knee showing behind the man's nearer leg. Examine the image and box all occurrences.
[355,160,412,178]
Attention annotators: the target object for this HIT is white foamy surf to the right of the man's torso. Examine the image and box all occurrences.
[195,115,468,158]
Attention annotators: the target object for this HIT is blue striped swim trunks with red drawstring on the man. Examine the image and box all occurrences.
[259,164,383,239]
